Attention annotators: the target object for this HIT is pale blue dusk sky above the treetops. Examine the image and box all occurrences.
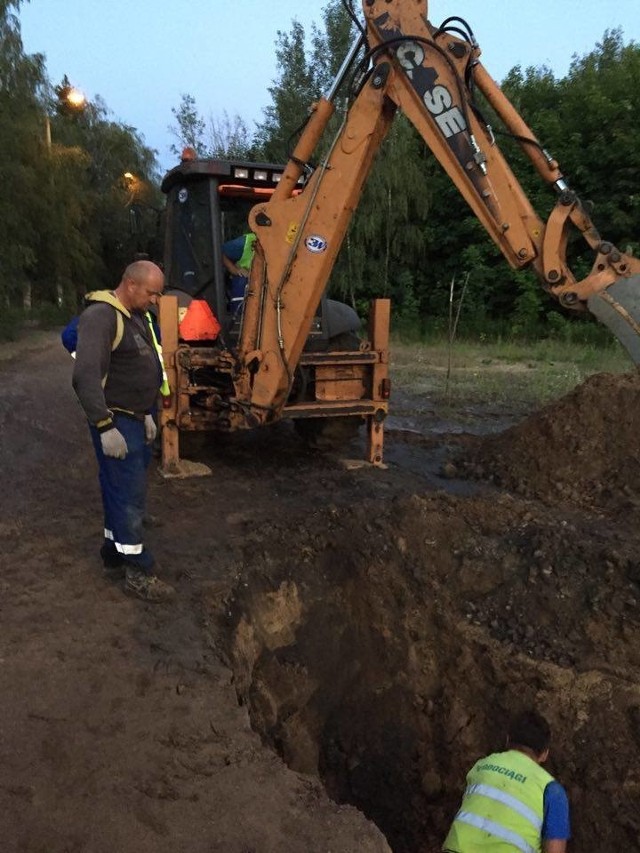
[19,0,640,170]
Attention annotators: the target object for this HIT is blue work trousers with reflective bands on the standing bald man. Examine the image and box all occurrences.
[89,413,154,574]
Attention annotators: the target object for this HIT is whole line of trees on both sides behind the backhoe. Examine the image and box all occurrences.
[0,0,640,346]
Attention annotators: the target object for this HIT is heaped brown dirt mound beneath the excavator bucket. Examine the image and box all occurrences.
[461,372,640,509]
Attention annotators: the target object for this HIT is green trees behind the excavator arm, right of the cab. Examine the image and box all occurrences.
[251,10,640,340]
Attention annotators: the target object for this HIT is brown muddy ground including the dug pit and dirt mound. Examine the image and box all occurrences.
[0,335,640,853]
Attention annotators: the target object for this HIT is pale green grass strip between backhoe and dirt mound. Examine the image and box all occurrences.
[390,338,635,408]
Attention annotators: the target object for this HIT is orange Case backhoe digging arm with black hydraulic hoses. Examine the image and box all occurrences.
[235,0,640,422]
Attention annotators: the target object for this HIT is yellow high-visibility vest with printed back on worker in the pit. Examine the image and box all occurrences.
[442,749,553,853]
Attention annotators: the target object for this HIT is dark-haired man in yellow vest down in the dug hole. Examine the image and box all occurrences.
[442,711,570,853]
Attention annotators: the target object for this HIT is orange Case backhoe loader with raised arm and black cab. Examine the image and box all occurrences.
[155,0,640,472]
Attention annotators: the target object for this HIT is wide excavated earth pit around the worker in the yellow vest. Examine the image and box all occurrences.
[225,372,640,853]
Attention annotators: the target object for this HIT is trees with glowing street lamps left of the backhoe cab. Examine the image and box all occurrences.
[0,0,161,337]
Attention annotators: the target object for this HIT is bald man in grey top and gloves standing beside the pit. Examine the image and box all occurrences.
[73,261,175,601]
